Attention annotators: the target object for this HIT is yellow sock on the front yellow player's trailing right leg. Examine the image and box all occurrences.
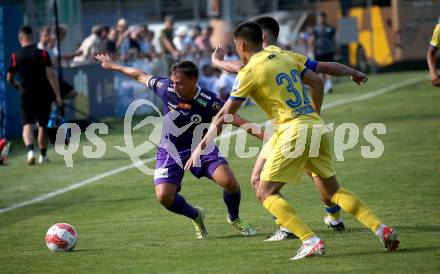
[332,187,382,232]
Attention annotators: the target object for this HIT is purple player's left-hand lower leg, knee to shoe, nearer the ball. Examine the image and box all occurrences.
[154,183,208,239]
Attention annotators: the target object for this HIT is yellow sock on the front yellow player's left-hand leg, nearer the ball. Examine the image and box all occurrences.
[263,195,314,241]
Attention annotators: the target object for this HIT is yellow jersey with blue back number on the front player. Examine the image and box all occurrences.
[229,50,322,126]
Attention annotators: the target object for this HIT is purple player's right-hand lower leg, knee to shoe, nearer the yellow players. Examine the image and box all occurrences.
[212,165,257,236]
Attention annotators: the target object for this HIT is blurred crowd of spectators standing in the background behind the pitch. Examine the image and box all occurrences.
[38,13,336,99]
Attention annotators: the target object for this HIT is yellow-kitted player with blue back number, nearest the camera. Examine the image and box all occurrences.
[185,22,399,260]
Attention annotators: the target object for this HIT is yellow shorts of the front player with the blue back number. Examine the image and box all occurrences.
[260,124,335,183]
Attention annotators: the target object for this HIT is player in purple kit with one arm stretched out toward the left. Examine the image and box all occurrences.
[95,54,258,239]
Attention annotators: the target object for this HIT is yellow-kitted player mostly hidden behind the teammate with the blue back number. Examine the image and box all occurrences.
[212,16,368,241]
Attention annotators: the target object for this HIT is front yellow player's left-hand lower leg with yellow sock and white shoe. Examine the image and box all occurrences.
[257,181,325,260]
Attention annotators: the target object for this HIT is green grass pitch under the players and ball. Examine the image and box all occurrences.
[0,72,440,273]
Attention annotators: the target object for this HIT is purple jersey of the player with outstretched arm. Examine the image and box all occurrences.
[147,76,224,154]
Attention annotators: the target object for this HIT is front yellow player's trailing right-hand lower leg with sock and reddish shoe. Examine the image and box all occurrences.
[316,176,400,251]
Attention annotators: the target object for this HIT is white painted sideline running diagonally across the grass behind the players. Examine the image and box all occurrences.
[0,76,426,214]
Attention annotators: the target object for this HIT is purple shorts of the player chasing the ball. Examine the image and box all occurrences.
[154,147,228,191]
